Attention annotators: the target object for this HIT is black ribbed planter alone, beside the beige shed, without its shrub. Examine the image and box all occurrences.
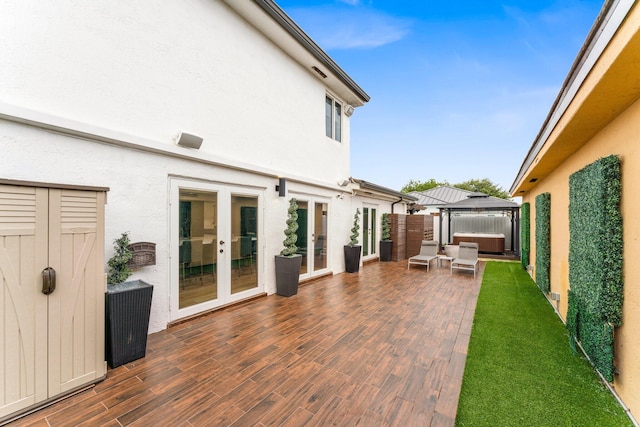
[105,280,153,368]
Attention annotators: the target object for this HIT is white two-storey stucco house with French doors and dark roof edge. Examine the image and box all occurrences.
[0,0,413,350]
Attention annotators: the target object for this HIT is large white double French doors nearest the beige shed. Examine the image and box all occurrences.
[170,179,263,320]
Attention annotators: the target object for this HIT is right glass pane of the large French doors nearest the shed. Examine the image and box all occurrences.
[230,195,260,294]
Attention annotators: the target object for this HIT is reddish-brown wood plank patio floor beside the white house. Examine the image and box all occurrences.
[10,261,484,426]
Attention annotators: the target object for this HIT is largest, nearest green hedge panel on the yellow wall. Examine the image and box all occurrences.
[567,156,623,381]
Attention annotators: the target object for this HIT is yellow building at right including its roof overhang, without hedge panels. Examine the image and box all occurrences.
[514,3,640,419]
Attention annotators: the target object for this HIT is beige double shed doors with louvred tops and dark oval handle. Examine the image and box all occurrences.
[0,184,106,421]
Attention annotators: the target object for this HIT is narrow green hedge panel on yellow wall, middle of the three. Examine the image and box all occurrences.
[536,193,551,294]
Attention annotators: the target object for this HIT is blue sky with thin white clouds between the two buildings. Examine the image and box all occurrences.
[276,0,603,195]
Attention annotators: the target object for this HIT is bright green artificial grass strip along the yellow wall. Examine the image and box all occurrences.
[456,262,633,427]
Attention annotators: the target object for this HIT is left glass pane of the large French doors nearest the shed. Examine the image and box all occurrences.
[178,189,218,308]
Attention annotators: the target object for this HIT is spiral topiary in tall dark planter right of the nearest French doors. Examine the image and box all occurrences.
[275,199,302,297]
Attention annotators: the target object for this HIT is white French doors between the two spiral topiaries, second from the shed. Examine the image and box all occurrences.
[296,199,329,278]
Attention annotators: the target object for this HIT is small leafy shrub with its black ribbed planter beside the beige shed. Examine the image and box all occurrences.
[105,233,153,368]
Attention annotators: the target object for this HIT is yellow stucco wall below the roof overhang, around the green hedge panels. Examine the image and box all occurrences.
[523,96,640,417]
